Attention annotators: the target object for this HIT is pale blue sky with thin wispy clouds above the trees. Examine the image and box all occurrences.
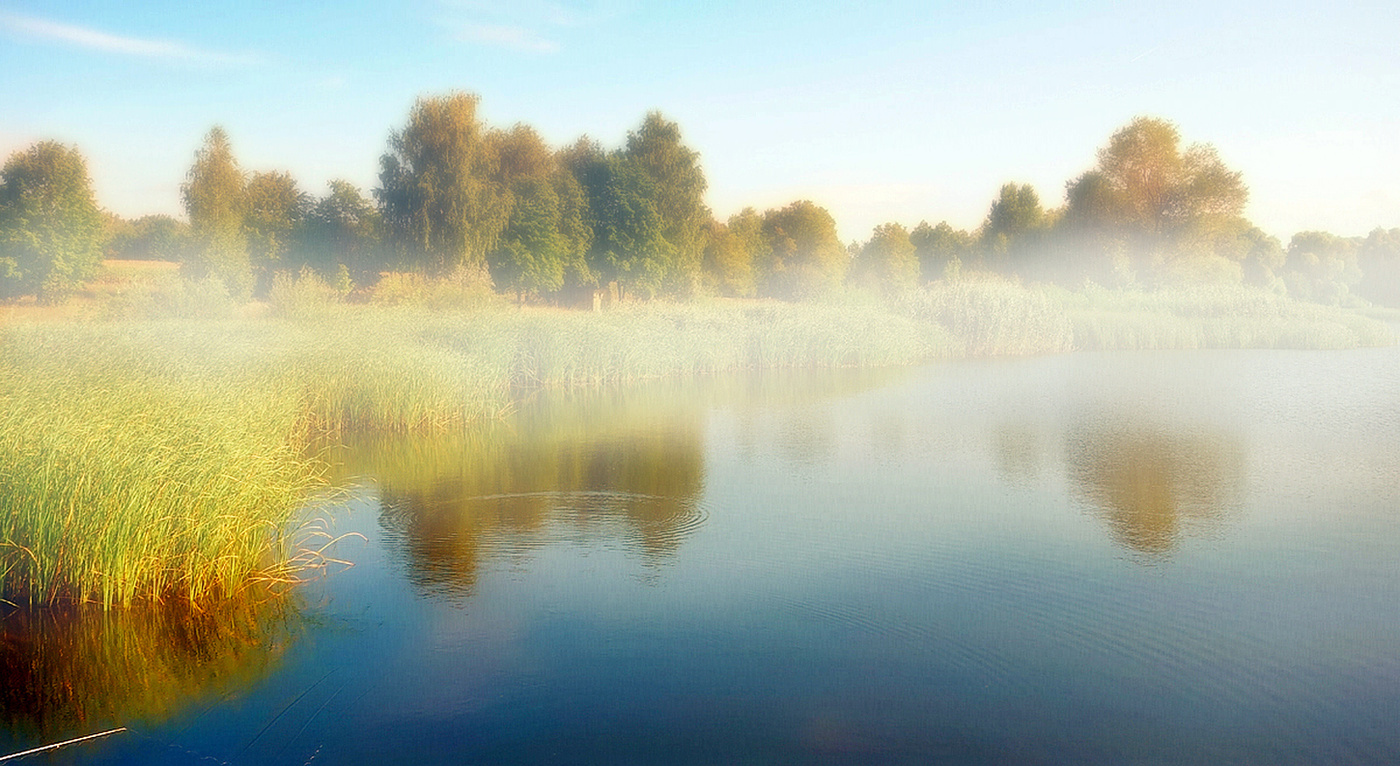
[0,0,1400,244]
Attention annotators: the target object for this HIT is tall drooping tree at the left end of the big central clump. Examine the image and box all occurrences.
[374,91,510,273]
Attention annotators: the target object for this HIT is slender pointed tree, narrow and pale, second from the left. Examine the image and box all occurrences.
[181,125,253,297]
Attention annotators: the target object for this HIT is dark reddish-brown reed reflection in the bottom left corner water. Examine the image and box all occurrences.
[0,597,301,742]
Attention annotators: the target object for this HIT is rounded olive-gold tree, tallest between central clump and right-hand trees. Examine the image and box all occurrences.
[759,199,848,300]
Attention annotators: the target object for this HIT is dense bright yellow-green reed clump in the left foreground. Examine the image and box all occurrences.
[0,328,316,605]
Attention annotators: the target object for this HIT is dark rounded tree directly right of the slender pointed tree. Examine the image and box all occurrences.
[244,171,311,290]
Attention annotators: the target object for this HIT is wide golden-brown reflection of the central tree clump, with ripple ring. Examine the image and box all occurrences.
[330,388,704,594]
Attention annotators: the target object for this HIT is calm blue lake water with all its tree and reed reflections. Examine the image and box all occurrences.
[0,349,1400,765]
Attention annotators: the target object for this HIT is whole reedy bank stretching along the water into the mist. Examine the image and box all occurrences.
[0,280,1394,606]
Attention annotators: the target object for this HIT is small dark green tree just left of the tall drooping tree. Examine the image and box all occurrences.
[302,179,388,284]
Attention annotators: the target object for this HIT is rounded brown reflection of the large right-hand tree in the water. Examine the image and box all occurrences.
[1065,420,1245,557]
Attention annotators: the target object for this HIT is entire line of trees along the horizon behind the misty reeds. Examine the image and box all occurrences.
[0,92,1400,304]
